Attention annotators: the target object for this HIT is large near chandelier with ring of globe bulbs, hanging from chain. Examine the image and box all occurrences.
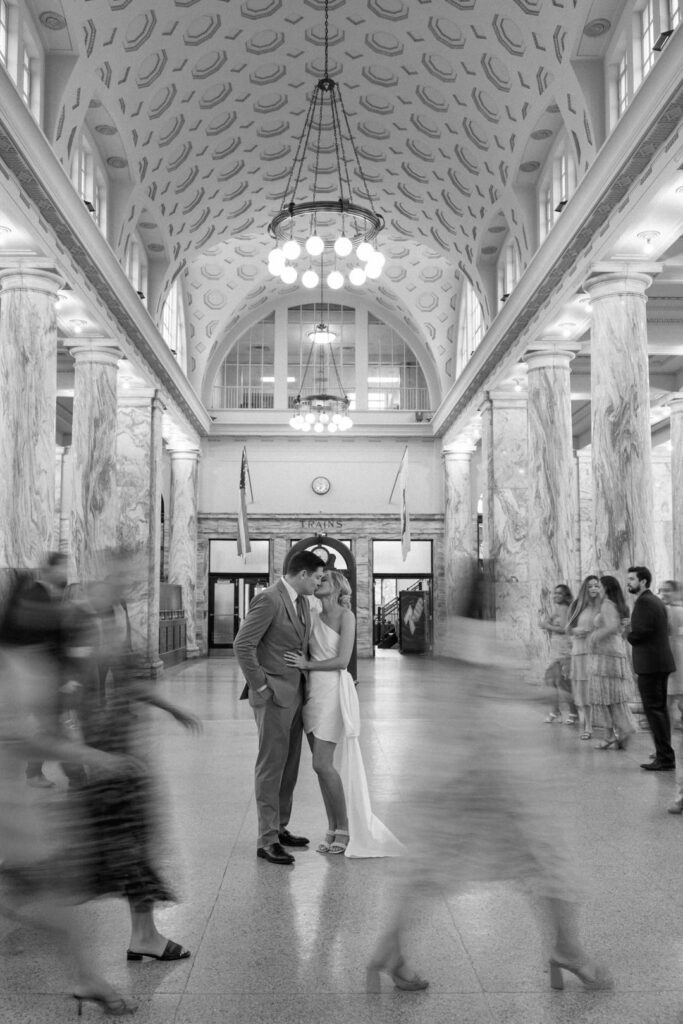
[268,0,385,290]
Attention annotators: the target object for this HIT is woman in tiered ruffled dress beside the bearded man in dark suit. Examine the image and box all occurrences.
[588,575,636,751]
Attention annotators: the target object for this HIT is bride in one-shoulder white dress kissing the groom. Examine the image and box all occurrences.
[285,569,404,857]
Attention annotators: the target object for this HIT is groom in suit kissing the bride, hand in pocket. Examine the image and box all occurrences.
[234,551,325,864]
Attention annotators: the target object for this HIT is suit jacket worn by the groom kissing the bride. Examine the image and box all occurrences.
[234,580,310,708]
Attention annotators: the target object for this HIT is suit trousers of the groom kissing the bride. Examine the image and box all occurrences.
[253,693,303,847]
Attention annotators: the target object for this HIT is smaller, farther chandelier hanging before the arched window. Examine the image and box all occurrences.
[290,301,353,434]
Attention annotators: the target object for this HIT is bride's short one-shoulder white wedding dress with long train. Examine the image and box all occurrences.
[303,607,405,857]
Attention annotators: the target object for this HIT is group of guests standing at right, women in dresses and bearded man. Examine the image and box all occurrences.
[541,565,683,774]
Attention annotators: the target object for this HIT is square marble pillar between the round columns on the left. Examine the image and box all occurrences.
[117,388,164,675]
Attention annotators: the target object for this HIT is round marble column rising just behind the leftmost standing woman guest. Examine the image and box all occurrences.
[524,348,575,668]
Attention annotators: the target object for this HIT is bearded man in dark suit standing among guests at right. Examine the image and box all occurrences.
[627,565,676,771]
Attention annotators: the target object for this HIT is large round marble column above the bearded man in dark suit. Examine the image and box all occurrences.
[585,263,659,580]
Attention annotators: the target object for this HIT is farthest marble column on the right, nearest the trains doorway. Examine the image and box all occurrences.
[444,445,477,657]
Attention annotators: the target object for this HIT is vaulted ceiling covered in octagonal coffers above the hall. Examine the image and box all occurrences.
[29,0,623,405]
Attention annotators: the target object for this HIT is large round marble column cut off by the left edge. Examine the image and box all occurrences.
[0,267,62,568]
